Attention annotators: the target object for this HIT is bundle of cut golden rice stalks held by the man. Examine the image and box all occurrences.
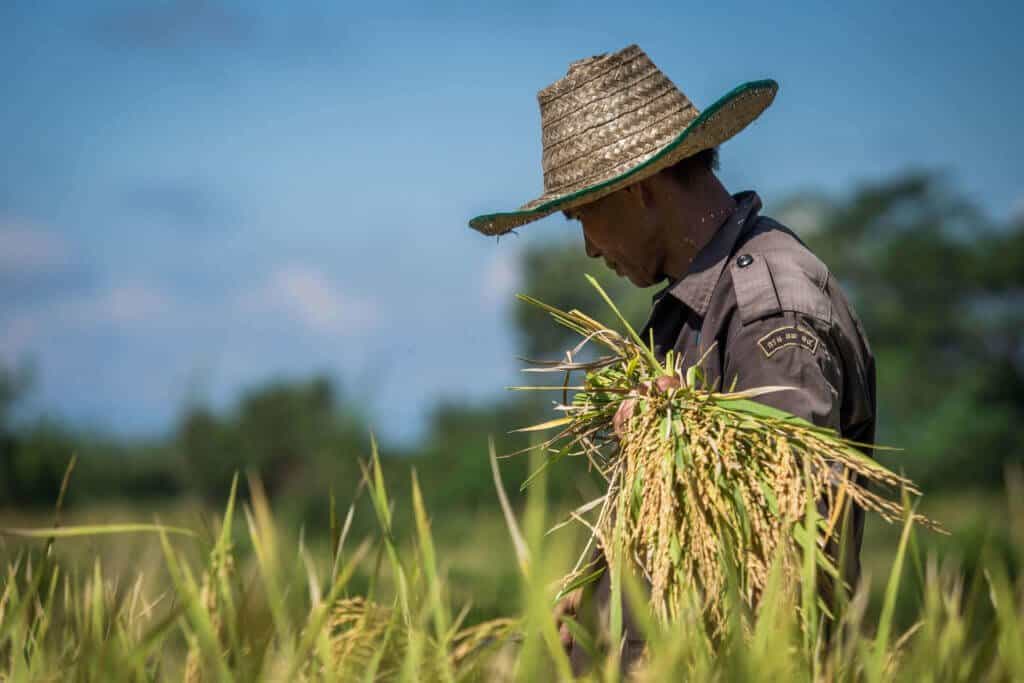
[514,275,935,630]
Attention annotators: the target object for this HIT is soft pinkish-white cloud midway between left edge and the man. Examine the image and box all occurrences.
[241,264,377,335]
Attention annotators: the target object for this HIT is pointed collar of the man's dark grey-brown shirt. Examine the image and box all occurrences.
[667,191,761,317]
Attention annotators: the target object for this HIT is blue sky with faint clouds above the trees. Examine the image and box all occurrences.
[0,0,1024,439]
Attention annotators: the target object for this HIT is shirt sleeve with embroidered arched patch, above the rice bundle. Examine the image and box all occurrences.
[722,311,843,431]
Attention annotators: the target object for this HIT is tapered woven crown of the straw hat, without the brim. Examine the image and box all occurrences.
[537,45,699,196]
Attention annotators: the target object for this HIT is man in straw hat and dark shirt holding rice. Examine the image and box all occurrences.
[470,45,876,668]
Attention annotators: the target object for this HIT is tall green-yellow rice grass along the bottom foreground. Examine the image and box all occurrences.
[0,446,1024,681]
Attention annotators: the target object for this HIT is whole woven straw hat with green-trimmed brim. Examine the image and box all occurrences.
[469,45,778,234]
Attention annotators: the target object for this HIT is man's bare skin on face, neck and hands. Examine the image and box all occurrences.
[555,166,736,648]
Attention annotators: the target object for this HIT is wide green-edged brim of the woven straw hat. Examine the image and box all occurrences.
[469,79,778,234]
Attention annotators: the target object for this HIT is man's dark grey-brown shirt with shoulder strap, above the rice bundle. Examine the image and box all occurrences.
[641,193,876,444]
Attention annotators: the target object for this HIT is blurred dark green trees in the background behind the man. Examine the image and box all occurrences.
[0,173,1024,612]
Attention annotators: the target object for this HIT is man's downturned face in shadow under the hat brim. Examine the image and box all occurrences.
[567,183,666,287]
